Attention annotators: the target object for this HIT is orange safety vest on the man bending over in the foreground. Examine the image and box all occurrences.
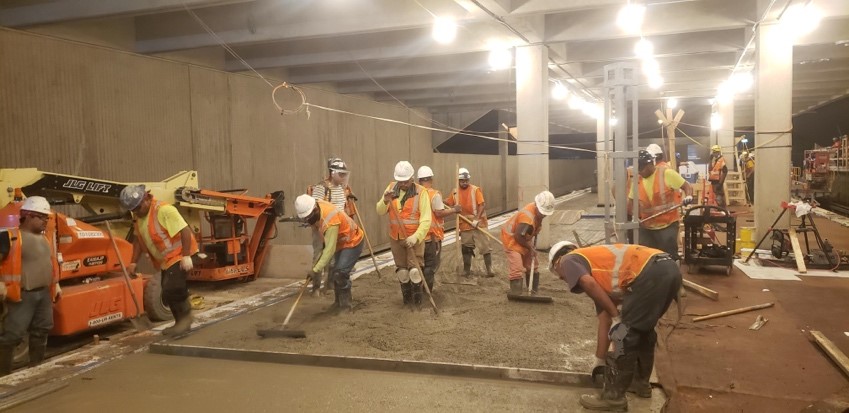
[569,244,663,294]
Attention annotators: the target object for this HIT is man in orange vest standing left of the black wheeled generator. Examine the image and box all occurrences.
[628,150,693,260]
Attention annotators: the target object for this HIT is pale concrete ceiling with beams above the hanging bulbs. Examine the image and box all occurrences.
[0,0,849,133]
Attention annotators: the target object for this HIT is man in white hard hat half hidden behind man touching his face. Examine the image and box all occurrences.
[416,166,460,291]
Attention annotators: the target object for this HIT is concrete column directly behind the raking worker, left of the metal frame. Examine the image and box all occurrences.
[516,45,551,249]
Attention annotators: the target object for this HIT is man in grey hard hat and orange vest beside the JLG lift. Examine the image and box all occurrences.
[120,185,198,335]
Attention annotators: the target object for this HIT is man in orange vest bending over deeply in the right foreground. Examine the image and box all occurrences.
[549,241,682,411]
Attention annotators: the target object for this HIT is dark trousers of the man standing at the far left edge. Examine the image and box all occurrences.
[0,287,53,347]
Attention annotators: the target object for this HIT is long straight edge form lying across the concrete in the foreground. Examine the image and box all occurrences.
[150,343,592,387]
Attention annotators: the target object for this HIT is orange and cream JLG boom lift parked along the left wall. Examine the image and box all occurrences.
[0,168,284,336]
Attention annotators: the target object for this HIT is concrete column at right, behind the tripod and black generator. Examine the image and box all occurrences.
[755,22,793,233]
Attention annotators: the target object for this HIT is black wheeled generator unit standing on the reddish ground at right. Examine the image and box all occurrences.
[684,205,737,275]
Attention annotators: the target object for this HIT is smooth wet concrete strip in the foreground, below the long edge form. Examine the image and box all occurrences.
[8,354,663,413]
